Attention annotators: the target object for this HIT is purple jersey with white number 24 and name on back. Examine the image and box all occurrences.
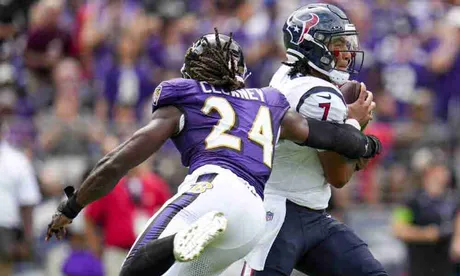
[153,79,289,196]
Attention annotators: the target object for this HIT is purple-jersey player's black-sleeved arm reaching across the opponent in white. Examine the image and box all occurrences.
[280,111,381,159]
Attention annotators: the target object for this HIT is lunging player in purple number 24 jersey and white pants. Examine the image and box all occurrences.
[46,30,380,276]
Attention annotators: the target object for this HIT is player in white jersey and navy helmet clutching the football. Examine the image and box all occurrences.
[242,4,387,276]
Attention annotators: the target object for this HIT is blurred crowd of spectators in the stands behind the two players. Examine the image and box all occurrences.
[0,0,460,275]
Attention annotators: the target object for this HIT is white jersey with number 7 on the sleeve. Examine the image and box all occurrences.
[265,65,347,210]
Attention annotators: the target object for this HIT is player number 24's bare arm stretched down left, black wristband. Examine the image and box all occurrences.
[46,106,182,240]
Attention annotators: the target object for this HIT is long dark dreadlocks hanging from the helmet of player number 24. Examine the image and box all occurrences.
[185,28,244,90]
